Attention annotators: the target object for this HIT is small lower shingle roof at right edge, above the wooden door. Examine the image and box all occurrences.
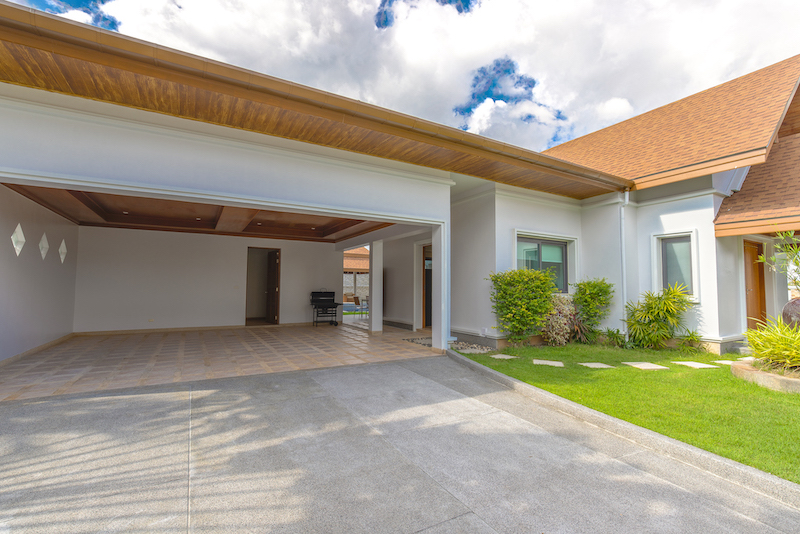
[714,135,800,237]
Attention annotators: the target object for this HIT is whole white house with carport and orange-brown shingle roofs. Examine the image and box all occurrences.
[0,0,800,360]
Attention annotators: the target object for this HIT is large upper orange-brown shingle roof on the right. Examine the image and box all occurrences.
[544,55,800,189]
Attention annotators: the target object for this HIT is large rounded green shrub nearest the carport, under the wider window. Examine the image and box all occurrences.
[489,269,556,344]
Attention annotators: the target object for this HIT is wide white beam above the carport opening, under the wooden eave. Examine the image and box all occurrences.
[0,89,452,226]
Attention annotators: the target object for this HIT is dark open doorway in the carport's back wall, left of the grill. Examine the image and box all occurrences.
[245,247,281,326]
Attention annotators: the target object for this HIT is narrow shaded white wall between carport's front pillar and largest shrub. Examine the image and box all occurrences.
[450,189,499,338]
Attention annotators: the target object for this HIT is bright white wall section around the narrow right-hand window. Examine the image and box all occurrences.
[628,191,721,342]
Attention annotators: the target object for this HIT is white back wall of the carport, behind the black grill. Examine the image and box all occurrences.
[74,227,343,332]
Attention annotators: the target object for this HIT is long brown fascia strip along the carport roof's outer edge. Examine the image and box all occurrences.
[0,3,634,196]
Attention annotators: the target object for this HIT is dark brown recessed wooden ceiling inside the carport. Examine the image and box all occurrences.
[4,184,391,243]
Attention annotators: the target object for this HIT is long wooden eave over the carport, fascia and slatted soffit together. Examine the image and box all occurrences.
[0,0,633,199]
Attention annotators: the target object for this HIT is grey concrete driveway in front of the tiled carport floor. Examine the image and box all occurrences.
[0,356,800,534]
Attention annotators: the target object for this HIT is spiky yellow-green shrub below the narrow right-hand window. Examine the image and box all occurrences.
[625,284,692,349]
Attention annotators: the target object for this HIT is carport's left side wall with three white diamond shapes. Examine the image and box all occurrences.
[0,186,78,360]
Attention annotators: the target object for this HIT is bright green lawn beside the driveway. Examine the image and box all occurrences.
[466,344,800,483]
